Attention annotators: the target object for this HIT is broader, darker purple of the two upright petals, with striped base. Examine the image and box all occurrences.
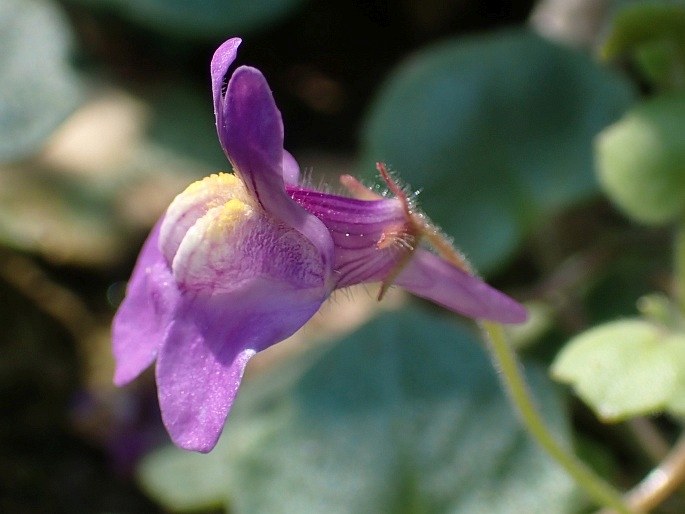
[219,66,333,262]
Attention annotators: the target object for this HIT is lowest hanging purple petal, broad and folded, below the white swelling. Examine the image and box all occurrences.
[157,279,325,452]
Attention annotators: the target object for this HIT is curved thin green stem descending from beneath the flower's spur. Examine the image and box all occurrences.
[481,321,634,514]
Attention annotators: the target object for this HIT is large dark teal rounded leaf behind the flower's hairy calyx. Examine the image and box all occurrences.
[362,30,633,269]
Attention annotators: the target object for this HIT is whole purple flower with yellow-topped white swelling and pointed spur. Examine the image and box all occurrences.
[113,38,526,452]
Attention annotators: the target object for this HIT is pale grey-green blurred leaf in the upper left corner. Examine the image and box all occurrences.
[0,0,82,161]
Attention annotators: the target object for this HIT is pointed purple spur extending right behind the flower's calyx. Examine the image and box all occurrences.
[395,250,528,323]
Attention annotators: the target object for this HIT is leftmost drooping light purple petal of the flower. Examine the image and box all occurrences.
[112,220,179,385]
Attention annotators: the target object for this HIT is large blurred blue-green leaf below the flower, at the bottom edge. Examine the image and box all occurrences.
[139,310,577,514]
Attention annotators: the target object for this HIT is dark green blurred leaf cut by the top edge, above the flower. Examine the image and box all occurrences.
[62,0,305,40]
